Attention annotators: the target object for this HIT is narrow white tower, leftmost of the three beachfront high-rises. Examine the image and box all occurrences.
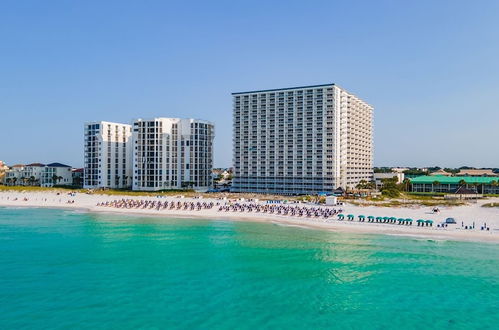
[83,121,132,188]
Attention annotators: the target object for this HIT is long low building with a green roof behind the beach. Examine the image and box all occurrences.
[410,175,499,194]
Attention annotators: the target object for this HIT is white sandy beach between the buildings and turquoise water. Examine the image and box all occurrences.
[0,191,499,243]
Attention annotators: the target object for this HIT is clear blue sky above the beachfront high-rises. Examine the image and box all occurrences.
[0,0,499,167]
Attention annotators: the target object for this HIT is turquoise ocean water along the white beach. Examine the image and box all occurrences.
[0,208,499,329]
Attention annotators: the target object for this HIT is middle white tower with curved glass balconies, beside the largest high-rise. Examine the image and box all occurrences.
[132,118,214,191]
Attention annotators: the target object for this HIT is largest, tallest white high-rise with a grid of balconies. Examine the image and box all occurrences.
[232,84,373,194]
